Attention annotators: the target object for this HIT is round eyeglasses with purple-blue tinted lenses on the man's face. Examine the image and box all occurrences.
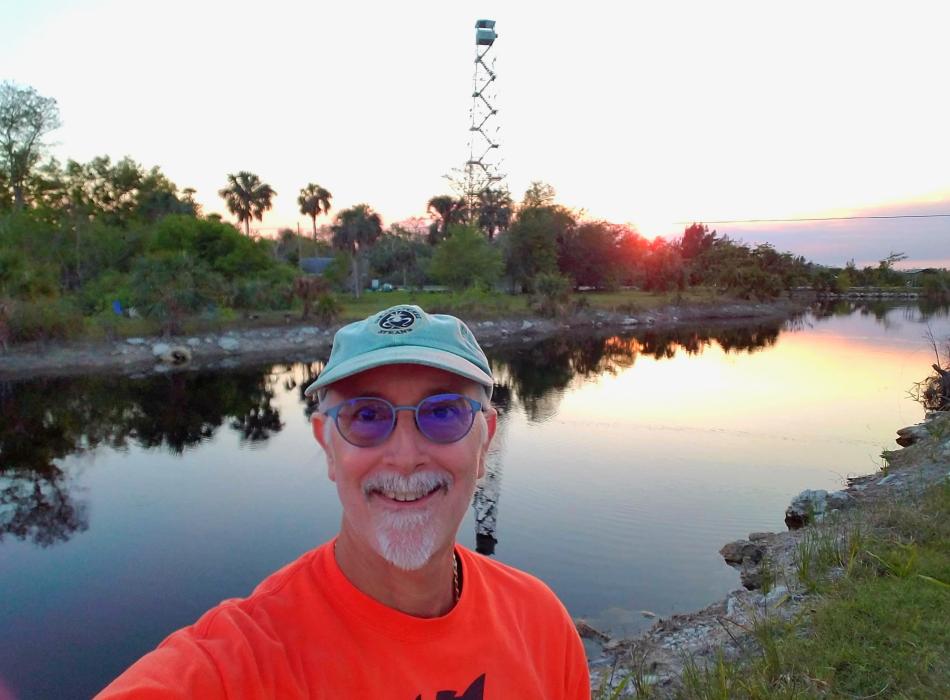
[324,394,482,447]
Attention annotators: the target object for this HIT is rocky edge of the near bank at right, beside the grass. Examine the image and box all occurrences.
[577,412,950,697]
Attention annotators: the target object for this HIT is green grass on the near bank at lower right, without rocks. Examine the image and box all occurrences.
[678,481,950,700]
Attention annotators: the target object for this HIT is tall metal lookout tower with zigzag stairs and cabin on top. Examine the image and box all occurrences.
[463,19,504,216]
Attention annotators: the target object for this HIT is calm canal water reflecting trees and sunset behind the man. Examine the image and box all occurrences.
[0,305,950,698]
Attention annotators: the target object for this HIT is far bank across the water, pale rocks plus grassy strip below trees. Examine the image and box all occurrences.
[0,290,806,379]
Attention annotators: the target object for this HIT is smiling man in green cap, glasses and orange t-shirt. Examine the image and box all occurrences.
[100,306,590,700]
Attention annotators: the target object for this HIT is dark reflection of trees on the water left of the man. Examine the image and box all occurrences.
[0,370,283,547]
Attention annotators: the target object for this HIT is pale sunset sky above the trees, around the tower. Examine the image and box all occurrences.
[0,0,950,266]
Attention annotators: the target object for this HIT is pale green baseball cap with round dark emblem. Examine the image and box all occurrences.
[304,304,494,398]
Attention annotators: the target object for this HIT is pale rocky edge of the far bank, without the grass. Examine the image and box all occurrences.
[0,300,805,380]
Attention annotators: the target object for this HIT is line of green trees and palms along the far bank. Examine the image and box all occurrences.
[0,83,950,341]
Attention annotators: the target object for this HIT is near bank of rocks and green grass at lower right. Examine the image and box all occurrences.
[592,411,950,700]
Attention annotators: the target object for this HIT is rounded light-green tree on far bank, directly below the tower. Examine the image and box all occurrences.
[429,224,502,289]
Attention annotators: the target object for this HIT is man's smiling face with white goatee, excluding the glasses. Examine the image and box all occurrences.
[313,365,497,570]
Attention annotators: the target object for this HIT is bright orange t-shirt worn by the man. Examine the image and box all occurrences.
[97,542,590,700]
